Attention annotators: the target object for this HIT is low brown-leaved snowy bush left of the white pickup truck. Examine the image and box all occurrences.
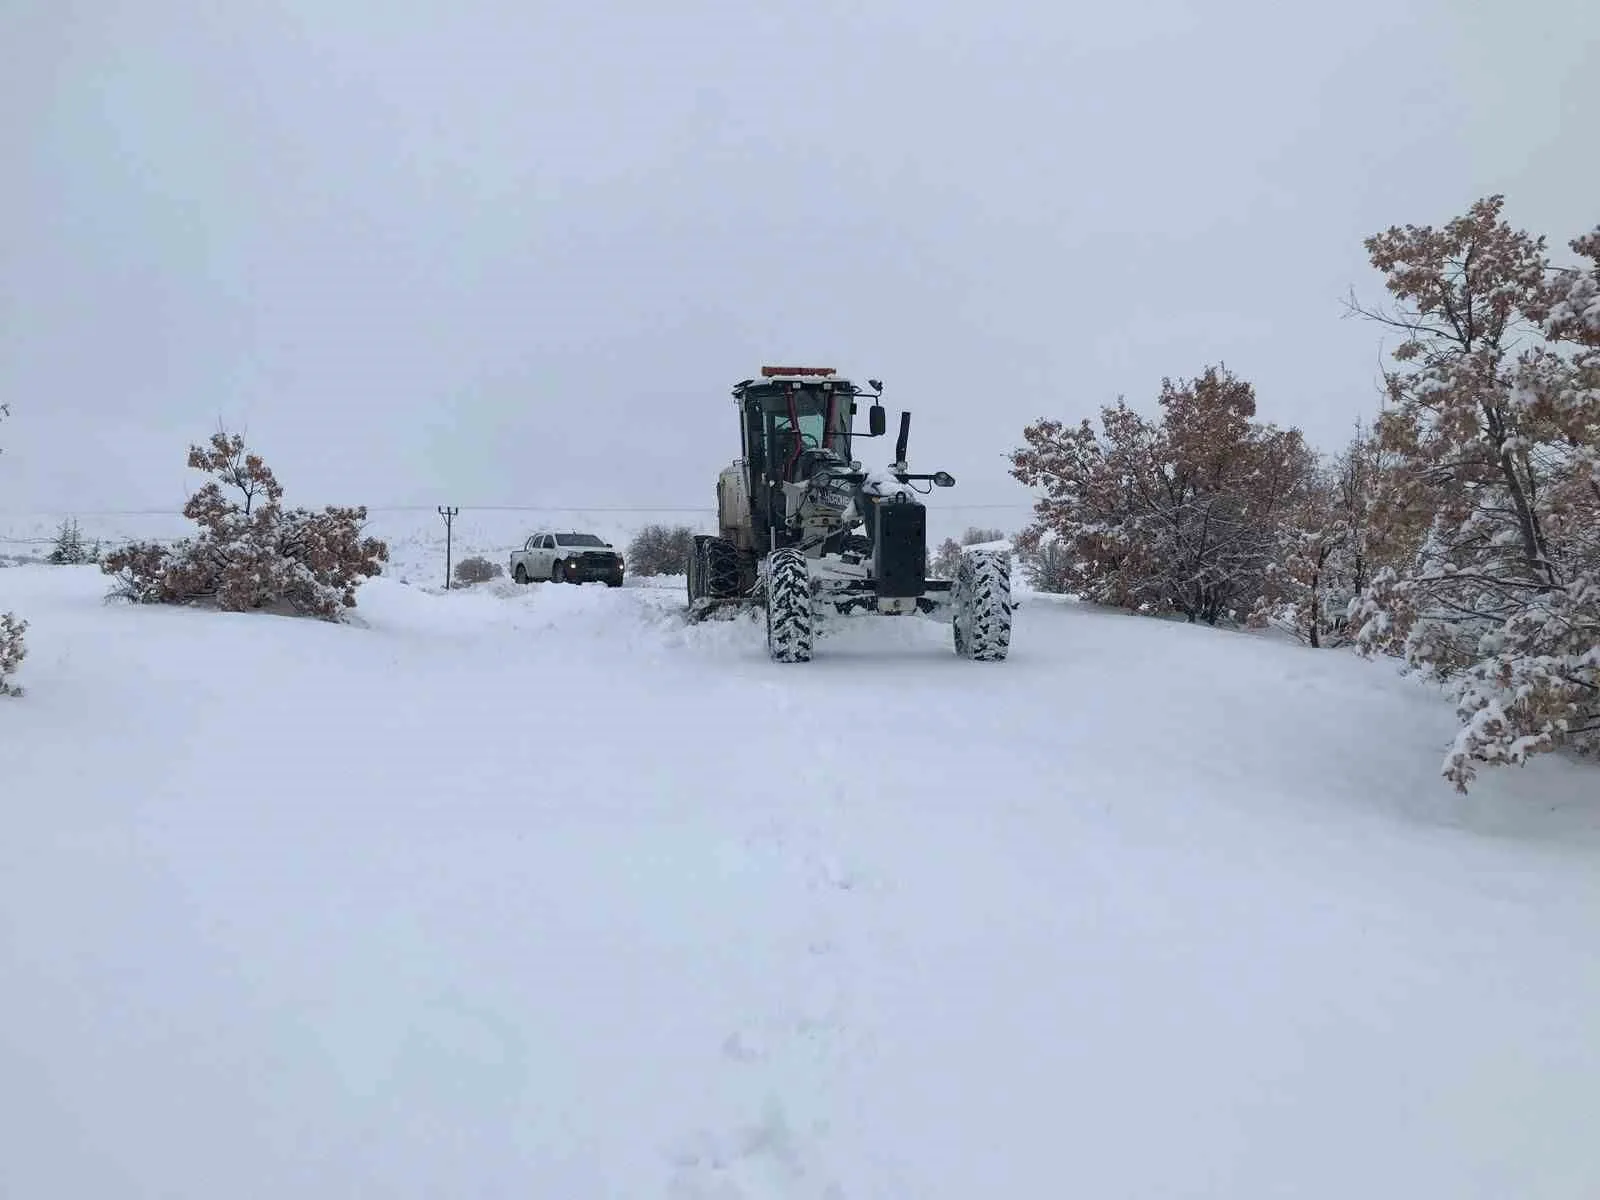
[101,432,389,621]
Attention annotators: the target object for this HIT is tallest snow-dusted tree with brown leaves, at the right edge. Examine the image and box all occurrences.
[1352,195,1600,792]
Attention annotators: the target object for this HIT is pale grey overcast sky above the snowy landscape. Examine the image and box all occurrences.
[0,0,1600,512]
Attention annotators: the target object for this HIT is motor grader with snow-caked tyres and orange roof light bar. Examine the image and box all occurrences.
[686,366,1011,662]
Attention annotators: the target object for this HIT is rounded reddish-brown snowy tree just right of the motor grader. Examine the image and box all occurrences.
[1011,366,1315,624]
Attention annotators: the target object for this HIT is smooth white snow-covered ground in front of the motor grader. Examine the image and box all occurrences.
[0,566,1600,1200]
